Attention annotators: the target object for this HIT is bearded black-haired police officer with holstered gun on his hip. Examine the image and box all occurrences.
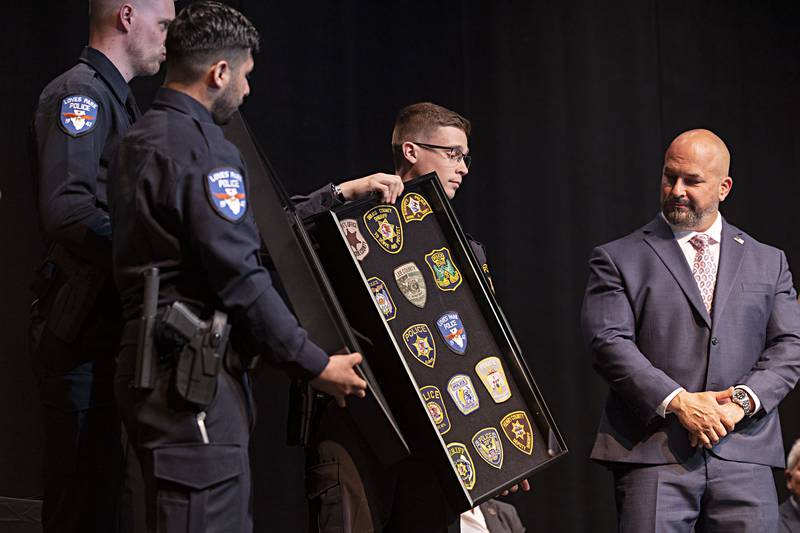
[110,1,366,533]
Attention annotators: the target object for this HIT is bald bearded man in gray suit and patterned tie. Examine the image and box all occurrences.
[582,130,800,533]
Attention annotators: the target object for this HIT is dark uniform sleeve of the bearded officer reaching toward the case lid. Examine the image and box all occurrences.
[179,162,328,379]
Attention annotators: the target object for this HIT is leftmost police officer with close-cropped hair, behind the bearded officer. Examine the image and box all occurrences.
[30,0,175,533]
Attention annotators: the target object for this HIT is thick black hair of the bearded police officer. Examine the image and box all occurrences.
[166,0,261,82]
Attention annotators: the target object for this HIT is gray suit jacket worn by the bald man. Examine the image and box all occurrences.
[582,215,800,467]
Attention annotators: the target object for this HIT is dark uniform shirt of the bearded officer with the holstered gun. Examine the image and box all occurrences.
[110,88,328,378]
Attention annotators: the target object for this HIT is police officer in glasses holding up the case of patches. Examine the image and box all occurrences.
[295,102,529,533]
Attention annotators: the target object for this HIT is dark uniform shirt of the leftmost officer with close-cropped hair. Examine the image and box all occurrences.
[31,47,138,271]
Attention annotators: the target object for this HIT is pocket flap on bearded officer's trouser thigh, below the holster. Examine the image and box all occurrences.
[153,444,244,490]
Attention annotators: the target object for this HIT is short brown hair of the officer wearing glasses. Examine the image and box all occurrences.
[392,102,472,168]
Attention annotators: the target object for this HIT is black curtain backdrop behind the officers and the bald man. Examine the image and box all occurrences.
[0,0,800,532]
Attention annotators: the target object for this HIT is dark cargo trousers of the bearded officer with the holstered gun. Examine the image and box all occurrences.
[114,346,254,533]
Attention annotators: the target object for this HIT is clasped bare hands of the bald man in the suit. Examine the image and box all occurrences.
[669,387,744,448]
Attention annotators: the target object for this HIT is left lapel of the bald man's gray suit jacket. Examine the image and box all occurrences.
[643,214,712,329]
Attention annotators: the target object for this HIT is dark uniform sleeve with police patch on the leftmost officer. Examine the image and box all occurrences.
[33,86,111,268]
